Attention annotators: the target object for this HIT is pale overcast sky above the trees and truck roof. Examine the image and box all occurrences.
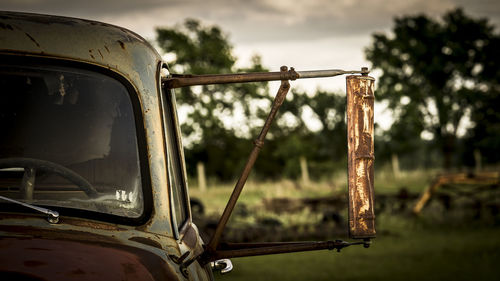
[0,0,500,128]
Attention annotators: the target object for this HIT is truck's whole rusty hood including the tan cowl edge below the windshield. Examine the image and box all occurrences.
[0,222,179,280]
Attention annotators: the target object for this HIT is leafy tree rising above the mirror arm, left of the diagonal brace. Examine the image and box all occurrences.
[156,19,271,180]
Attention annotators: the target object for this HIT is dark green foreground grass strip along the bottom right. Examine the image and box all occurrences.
[216,223,500,281]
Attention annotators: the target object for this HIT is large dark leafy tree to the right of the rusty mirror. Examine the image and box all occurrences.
[366,9,498,169]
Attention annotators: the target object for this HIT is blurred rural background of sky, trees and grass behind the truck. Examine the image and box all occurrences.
[0,0,500,280]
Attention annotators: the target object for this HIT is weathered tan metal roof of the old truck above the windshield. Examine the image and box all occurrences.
[0,11,161,88]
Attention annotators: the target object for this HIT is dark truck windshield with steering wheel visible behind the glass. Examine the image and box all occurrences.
[0,63,144,218]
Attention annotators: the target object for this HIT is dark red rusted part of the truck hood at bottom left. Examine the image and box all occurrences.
[0,229,178,281]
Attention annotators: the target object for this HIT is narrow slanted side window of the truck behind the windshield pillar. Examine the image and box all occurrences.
[162,86,189,231]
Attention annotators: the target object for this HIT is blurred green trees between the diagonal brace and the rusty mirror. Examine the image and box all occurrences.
[256,86,347,178]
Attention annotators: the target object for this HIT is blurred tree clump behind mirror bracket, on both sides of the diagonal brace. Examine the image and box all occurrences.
[156,19,352,180]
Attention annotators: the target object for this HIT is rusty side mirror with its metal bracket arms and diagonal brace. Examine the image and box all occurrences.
[162,66,375,268]
